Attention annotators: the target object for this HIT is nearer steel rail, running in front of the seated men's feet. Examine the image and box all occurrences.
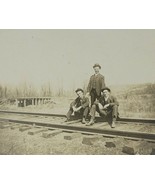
[2,118,155,142]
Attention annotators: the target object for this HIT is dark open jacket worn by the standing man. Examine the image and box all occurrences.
[87,73,105,96]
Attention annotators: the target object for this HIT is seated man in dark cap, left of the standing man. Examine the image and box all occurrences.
[66,88,89,124]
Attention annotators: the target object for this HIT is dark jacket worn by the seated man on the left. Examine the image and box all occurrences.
[70,96,89,109]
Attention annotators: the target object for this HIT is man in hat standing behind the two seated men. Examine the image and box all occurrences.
[87,64,105,106]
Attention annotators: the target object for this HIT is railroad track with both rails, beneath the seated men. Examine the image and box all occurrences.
[0,110,155,142]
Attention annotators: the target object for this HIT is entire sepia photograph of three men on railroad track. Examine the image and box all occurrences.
[0,29,155,155]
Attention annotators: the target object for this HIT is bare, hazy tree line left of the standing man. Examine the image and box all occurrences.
[0,82,86,100]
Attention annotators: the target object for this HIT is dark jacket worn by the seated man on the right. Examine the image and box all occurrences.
[99,95,119,107]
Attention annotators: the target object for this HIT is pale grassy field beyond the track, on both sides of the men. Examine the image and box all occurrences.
[0,84,155,118]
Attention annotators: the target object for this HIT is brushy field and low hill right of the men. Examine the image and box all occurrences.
[113,84,155,118]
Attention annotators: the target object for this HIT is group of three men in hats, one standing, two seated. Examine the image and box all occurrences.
[66,64,119,128]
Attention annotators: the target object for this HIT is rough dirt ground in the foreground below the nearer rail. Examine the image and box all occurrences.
[0,125,155,155]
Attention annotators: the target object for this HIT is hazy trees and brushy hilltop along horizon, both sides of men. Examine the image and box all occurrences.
[0,82,155,99]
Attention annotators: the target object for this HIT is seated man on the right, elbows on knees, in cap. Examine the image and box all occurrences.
[86,87,119,128]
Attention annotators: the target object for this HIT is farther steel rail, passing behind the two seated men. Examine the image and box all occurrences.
[0,110,155,123]
